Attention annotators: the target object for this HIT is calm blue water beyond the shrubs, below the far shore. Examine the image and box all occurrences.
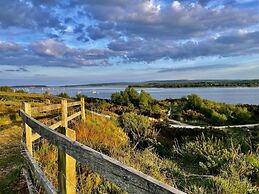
[17,86,259,105]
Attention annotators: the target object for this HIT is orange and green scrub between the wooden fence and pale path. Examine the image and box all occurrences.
[35,110,259,194]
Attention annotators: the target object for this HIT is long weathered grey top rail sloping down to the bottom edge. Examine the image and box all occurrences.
[20,110,184,194]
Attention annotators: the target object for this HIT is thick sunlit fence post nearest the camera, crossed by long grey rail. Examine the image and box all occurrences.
[58,100,76,194]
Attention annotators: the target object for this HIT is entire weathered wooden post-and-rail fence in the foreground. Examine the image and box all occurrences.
[20,98,187,194]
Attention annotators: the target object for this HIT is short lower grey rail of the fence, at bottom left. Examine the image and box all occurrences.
[22,143,58,194]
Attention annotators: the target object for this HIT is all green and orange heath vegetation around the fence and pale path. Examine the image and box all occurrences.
[0,88,259,194]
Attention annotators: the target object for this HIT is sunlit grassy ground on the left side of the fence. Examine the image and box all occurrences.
[0,92,61,194]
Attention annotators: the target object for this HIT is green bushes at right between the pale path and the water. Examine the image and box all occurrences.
[172,94,258,125]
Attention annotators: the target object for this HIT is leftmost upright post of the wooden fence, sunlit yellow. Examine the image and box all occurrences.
[23,102,32,155]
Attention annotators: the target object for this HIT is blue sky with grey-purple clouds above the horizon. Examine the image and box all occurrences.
[0,0,259,85]
